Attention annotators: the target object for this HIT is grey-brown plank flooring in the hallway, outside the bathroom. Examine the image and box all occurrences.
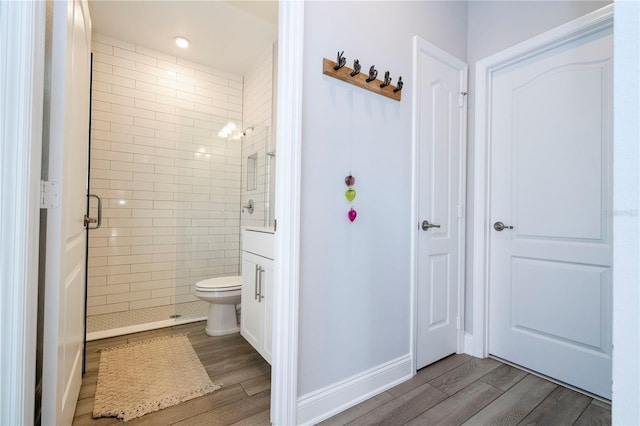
[320,355,611,426]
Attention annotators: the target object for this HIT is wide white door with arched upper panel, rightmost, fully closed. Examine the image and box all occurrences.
[489,27,613,398]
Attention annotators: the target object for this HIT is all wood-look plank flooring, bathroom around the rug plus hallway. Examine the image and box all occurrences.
[73,322,611,426]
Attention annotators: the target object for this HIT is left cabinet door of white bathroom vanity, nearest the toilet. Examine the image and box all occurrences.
[240,252,264,352]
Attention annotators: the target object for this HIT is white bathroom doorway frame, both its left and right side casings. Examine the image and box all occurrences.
[0,1,304,424]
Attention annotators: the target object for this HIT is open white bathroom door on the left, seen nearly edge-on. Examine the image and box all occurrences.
[42,0,91,425]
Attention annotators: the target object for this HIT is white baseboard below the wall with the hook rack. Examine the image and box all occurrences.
[297,354,415,425]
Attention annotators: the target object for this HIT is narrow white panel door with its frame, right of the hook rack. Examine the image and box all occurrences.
[414,38,467,368]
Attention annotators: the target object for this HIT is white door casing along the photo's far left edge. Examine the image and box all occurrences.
[0,2,46,424]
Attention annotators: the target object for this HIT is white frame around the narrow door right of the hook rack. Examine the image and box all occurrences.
[409,36,469,374]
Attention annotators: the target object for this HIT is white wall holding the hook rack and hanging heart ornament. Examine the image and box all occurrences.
[298,1,467,395]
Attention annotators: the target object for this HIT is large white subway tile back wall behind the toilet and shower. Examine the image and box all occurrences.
[88,34,248,331]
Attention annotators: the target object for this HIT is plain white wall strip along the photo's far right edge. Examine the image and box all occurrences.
[612,1,640,425]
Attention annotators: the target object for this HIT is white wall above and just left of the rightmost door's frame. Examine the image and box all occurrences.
[465,0,611,333]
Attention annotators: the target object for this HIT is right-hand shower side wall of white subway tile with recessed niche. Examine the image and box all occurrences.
[242,45,275,226]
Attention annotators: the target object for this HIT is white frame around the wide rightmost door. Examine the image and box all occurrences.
[465,4,613,358]
